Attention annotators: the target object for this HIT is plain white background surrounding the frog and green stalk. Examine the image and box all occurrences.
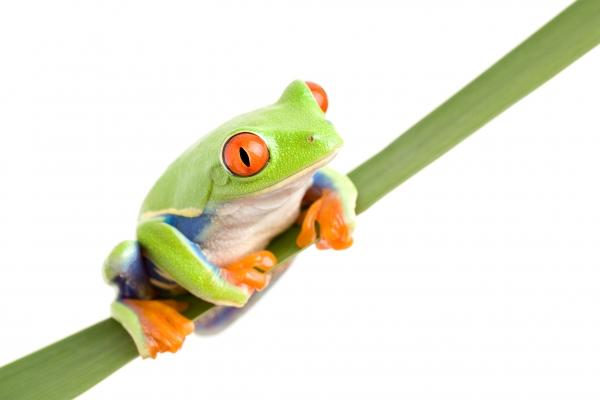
[0,0,600,400]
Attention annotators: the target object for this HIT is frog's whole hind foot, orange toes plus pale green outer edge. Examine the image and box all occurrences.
[112,299,194,358]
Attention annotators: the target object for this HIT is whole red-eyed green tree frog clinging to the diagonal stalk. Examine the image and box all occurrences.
[103,80,357,358]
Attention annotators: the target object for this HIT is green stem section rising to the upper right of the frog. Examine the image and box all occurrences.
[349,0,600,212]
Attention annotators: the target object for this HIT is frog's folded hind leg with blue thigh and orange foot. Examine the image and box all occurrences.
[104,241,194,358]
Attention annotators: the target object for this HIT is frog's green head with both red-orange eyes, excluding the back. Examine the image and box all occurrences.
[210,81,342,201]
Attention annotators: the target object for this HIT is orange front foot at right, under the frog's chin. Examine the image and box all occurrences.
[296,189,352,250]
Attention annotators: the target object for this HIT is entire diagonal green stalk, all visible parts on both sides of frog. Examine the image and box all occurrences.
[0,0,600,400]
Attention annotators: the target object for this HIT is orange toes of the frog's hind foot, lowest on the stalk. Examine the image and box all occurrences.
[123,299,194,358]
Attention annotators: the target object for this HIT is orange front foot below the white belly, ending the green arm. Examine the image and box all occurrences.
[224,250,277,291]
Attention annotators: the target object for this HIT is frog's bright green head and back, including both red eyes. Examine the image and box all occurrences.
[142,81,342,216]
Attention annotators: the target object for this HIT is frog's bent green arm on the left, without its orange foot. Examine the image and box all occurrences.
[137,219,252,307]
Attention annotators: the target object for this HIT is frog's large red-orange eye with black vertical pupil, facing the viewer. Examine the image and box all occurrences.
[223,132,269,176]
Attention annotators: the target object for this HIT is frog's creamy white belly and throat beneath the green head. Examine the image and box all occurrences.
[198,173,313,267]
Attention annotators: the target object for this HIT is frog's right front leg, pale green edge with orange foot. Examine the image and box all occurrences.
[296,168,357,250]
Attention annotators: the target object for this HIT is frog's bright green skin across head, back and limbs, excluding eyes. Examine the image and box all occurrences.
[104,81,356,355]
